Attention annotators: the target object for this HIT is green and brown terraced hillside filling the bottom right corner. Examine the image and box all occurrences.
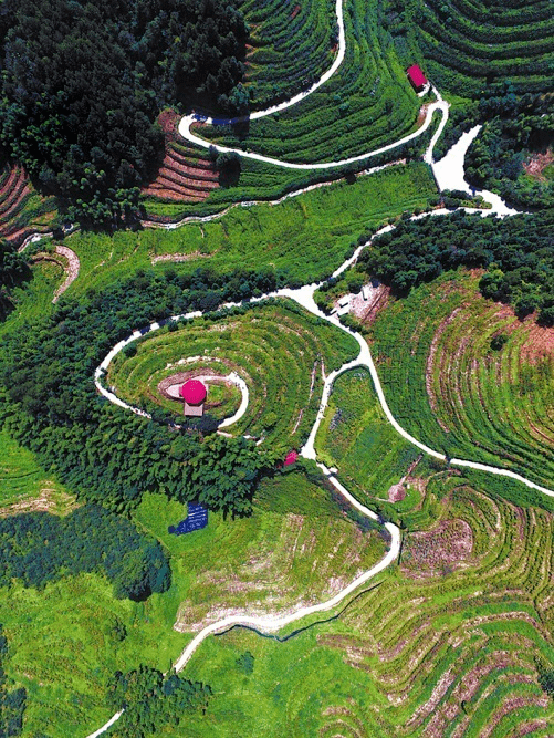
[183,474,554,738]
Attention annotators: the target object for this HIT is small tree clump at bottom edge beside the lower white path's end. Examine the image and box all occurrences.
[106,664,211,738]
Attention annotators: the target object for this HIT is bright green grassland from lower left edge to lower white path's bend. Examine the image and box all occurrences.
[0,472,385,738]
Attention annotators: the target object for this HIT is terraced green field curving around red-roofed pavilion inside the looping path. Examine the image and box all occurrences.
[106,301,358,448]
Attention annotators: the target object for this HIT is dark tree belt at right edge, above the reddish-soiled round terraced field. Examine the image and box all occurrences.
[359,210,554,326]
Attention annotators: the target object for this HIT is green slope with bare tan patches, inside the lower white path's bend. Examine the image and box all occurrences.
[136,472,387,633]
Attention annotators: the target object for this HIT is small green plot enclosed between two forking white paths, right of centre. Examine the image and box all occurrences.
[316,368,418,504]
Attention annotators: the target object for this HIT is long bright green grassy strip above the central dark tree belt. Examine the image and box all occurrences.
[62,164,436,295]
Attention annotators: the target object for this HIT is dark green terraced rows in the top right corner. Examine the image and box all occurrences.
[388,0,554,97]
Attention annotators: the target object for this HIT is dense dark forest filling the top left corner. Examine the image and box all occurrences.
[0,0,248,225]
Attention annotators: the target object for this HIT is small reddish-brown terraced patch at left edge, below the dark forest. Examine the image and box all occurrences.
[0,165,56,241]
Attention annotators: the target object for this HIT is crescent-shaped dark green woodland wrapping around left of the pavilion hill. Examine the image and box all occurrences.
[0,269,275,515]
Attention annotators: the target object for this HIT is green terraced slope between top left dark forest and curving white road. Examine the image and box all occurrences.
[241,0,337,110]
